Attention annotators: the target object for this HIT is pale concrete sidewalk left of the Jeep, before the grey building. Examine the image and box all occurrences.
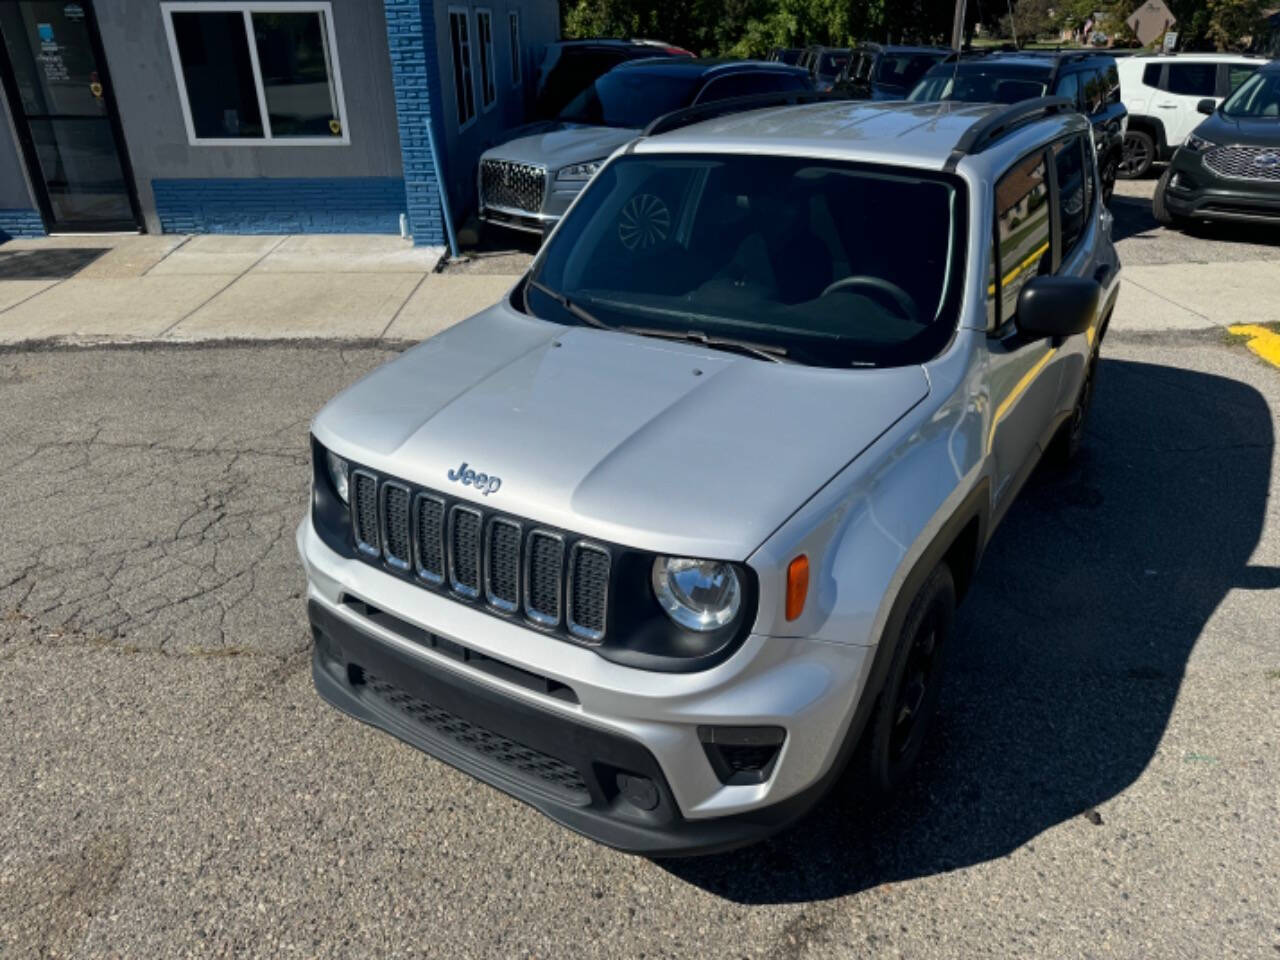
[0,236,516,343]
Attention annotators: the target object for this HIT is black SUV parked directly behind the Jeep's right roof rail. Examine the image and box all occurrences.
[906,50,1128,201]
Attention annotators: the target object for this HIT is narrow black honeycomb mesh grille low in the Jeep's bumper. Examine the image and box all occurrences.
[365,673,591,804]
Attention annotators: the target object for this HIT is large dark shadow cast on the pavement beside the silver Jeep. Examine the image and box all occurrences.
[662,358,1280,904]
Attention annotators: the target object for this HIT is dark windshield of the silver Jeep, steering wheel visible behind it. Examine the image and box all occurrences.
[526,155,964,367]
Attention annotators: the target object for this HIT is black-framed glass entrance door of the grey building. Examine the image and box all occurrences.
[0,0,138,232]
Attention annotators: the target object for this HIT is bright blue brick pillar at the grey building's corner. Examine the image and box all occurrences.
[384,0,444,246]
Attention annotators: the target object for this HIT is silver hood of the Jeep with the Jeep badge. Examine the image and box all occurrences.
[314,303,929,559]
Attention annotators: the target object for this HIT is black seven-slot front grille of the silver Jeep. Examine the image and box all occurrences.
[351,468,612,643]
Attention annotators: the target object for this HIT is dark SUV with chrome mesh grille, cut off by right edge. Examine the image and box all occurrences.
[1151,60,1280,227]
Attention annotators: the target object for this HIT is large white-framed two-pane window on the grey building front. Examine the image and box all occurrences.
[161,3,351,146]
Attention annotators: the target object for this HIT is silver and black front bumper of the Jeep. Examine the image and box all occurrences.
[297,520,874,856]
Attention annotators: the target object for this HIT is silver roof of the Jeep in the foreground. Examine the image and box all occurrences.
[636,100,1085,169]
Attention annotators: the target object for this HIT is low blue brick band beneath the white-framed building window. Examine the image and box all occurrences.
[151,177,406,233]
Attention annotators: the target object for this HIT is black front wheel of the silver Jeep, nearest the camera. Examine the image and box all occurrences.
[864,563,956,796]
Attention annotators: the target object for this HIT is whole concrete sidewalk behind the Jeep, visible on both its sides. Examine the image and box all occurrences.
[0,207,1280,343]
